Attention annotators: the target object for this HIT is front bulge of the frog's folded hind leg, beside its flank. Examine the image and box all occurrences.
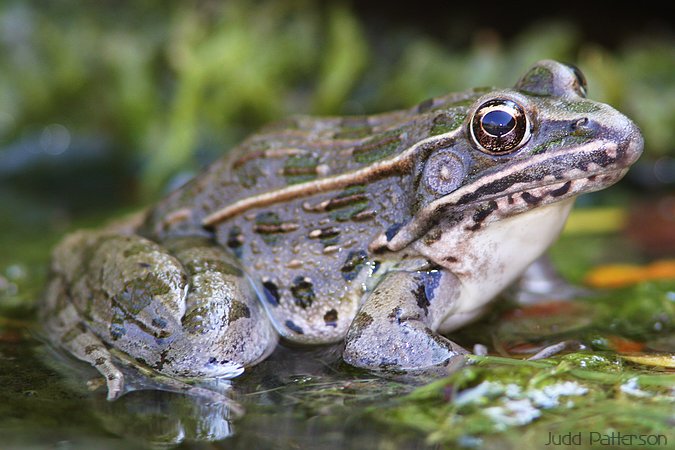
[162,237,278,377]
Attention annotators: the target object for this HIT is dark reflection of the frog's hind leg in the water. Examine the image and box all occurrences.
[44,346,244,448]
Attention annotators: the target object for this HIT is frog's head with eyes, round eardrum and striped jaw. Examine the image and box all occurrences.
[380,60,643,250]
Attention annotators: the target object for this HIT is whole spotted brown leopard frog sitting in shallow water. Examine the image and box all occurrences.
[40,60,643,399]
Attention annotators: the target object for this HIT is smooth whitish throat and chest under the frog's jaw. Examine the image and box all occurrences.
[434,198,574,332]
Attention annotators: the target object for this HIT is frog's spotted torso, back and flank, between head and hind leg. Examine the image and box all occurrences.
[143,93,476,342]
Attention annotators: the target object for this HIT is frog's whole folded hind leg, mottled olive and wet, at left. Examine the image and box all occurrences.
[42,232,277,398]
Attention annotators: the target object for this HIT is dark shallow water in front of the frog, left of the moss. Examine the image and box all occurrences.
[0,318,423,449]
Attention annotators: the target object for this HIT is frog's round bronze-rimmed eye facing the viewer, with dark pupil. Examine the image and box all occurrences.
[470,99,530,155]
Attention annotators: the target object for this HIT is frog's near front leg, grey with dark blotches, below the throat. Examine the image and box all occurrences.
[343,270,467,370]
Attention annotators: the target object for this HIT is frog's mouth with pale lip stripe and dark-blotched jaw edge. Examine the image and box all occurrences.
[380,137,642,251]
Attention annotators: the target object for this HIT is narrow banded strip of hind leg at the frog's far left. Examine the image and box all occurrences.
[40,277,124,400]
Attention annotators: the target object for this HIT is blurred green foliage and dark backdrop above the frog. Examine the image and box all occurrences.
[0,0,675,216]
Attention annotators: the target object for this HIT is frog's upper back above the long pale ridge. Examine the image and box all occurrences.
[152,91,478,215]
